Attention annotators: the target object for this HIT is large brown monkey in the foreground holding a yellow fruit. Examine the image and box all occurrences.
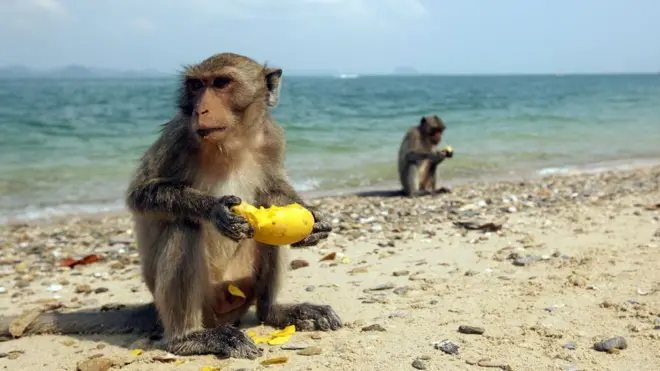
[0,53,342,359]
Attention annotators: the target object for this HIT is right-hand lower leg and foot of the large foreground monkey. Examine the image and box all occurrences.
[257,245,343,331]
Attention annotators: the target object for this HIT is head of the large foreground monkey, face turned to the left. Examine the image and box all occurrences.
[179,53,282,143]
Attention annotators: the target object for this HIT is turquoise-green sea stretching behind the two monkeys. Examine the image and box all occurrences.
[0,74,660,222]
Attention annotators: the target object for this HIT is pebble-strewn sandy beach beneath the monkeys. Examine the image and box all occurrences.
[0,167,660,371]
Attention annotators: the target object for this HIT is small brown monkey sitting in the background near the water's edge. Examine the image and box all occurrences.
[398,115,453,197]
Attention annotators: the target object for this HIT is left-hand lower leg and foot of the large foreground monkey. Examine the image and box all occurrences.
[154,222,262,359]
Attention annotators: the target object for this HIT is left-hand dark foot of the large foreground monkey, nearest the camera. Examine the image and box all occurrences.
[167,325,263,359]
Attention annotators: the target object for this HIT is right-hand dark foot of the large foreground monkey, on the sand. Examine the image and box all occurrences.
[266,303,343,331]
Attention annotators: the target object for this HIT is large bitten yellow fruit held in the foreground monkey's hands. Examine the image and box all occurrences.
[232,202,314,245]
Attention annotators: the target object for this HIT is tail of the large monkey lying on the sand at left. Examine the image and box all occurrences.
[0,303,162,338]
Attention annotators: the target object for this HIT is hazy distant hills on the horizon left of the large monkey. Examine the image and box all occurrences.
[0,64,171,79]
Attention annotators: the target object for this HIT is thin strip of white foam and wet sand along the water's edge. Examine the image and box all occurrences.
[3,158,660,226]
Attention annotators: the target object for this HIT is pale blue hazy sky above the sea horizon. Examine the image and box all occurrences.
[0,0,660,74]
